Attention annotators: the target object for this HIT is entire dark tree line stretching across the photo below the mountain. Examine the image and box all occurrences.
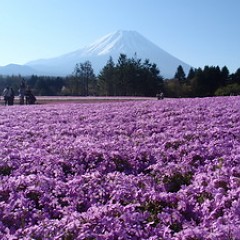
[0,54,240,97]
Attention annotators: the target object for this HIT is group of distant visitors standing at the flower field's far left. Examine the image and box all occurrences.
[2,80,37,106]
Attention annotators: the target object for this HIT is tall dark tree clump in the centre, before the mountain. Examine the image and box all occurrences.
[99,54,163,96]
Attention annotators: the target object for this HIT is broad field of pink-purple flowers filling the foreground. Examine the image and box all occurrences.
[0,97,240,240]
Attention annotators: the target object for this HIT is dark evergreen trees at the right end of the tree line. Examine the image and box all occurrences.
[168,66,240,97]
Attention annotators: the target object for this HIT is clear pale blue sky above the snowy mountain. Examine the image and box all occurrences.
[0,0,240,72]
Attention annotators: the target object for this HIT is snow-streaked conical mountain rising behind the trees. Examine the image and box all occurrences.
[0,31,191,78]
